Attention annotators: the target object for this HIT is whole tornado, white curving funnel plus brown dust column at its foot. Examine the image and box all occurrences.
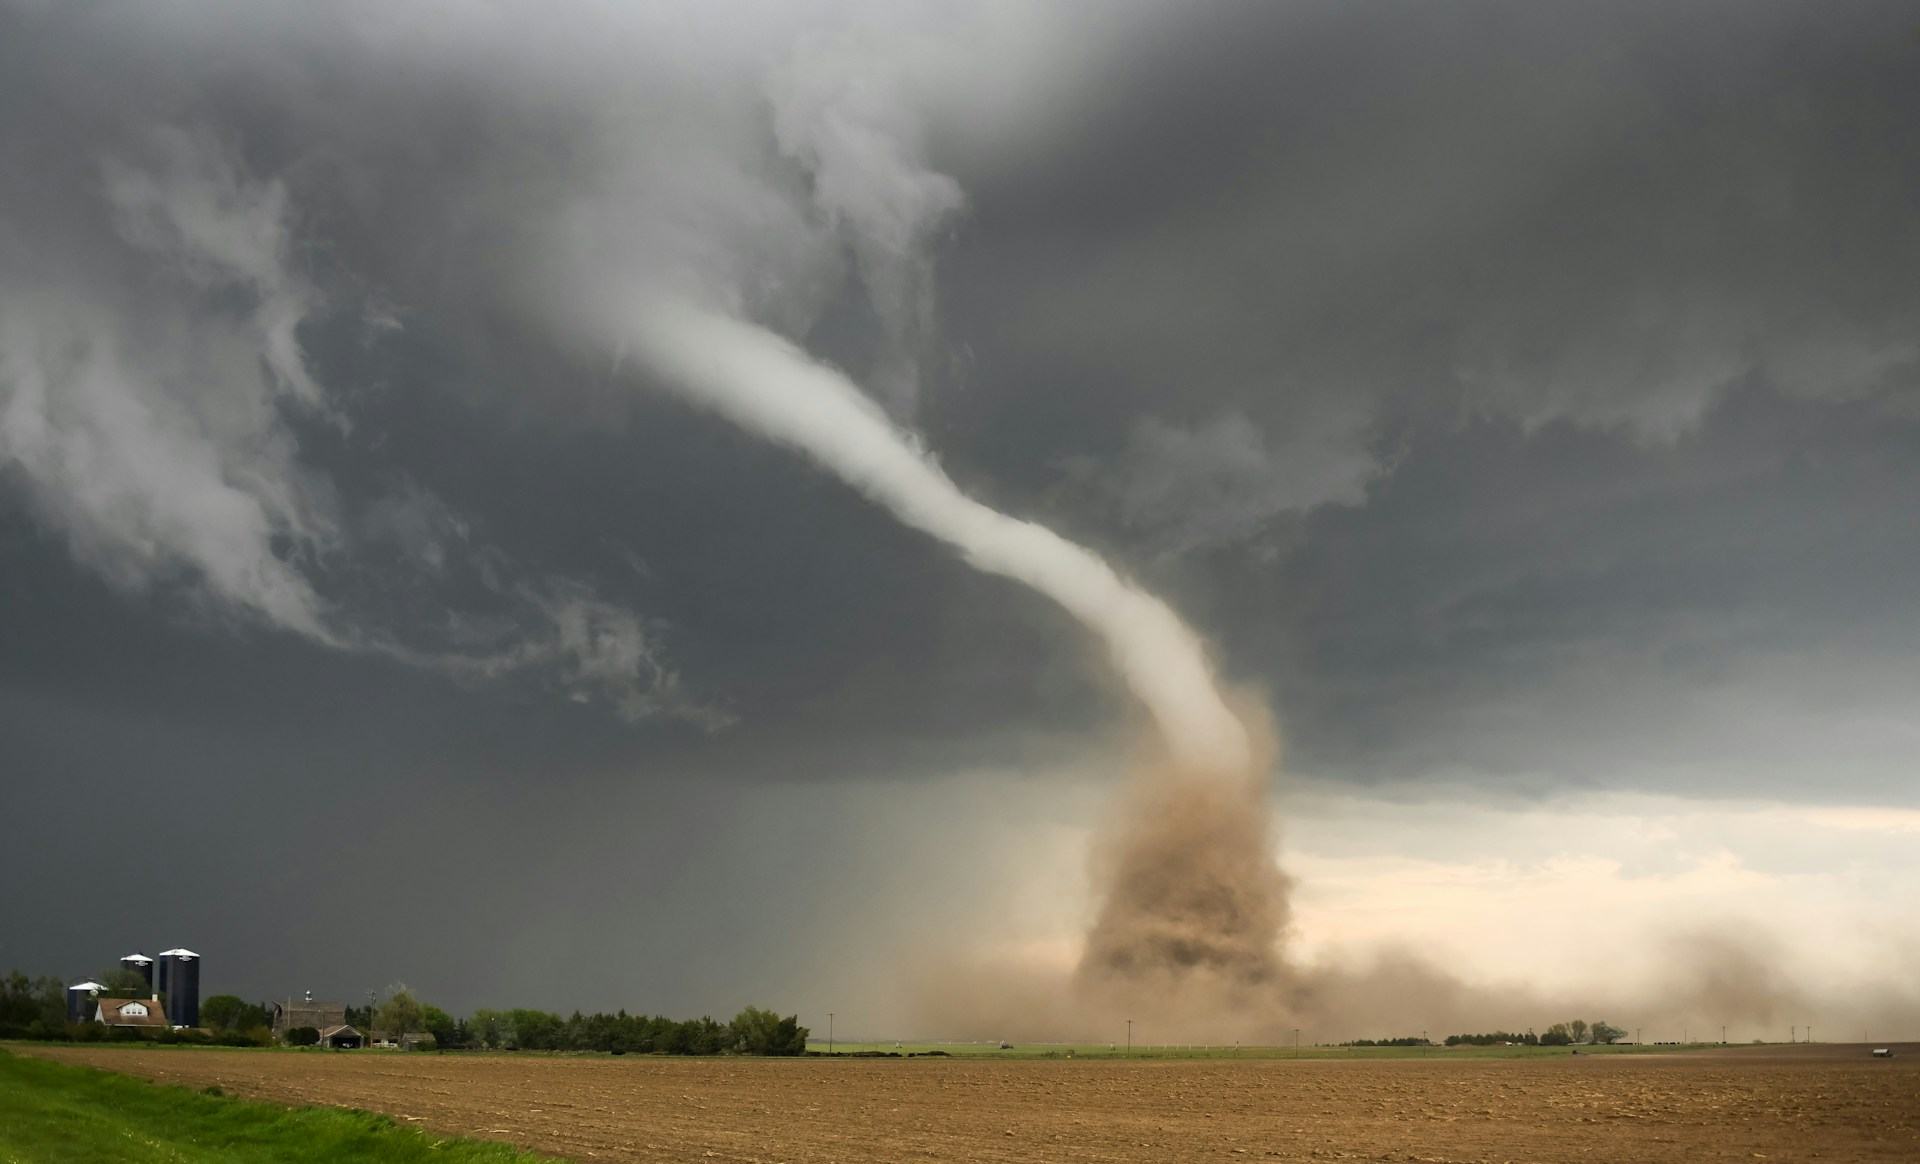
[624,302,1286,1010]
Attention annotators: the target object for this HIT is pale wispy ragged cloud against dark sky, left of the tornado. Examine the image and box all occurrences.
[0,127,730,728]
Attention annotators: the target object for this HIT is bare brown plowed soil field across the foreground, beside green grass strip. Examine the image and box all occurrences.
[15,1047,1920,1164]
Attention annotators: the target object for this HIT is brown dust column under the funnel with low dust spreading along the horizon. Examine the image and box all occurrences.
[899,714,1920,1047]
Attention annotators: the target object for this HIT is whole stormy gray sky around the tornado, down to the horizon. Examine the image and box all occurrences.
[0,2,1920,1030]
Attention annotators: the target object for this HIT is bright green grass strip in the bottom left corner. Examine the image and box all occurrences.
[0,1051,547,1164]
